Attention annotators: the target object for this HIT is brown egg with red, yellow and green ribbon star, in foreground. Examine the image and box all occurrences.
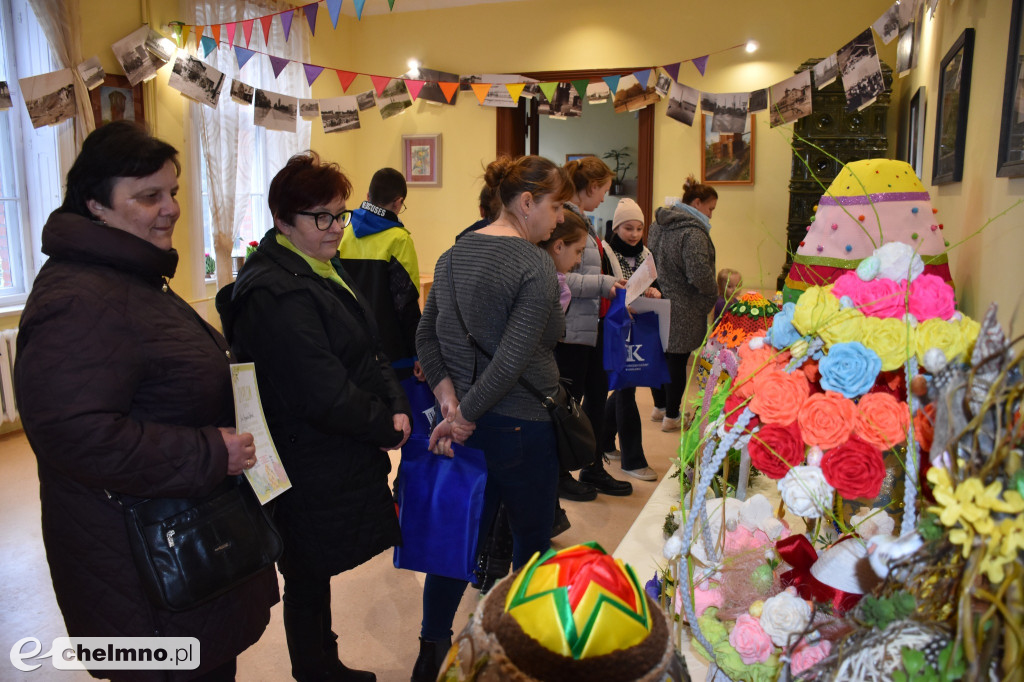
[439,543,689,682]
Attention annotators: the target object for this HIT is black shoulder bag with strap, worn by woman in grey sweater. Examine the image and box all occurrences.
[447,251,597,471]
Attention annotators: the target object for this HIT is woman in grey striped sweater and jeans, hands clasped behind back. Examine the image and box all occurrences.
[412,157,572,682]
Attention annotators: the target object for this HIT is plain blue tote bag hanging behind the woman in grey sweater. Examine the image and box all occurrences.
[394,436,487,581]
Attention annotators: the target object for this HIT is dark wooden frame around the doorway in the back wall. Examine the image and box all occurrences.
[496,69,654,231]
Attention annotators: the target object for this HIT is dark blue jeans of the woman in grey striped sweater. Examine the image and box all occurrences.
[420,413,558,641]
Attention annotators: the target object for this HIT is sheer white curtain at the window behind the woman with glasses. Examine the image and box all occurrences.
[185,0,311,289]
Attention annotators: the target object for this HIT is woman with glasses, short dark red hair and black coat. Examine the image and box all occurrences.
[217,152,411,682]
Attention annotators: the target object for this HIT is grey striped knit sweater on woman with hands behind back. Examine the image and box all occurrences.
[416,232,565,421]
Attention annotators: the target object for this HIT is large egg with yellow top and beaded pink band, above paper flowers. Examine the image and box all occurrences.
[783,159,952,302]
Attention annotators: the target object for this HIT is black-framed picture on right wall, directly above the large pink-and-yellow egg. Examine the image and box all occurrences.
[932,29,974,184]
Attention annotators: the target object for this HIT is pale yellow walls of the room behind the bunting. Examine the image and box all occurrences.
[12,0,1024,331]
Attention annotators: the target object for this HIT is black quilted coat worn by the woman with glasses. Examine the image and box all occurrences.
[217,229,411,578]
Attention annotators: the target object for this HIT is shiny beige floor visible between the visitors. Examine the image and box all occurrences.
[0,388,679,682]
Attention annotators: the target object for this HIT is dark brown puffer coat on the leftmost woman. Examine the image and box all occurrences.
[14,213,279,681]
